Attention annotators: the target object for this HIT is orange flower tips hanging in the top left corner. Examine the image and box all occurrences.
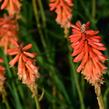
[0,0,21,16]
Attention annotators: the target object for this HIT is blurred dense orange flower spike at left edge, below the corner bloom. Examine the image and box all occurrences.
[0,15,18,53]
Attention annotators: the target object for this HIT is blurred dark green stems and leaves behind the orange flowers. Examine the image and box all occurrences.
[0,0,109,109]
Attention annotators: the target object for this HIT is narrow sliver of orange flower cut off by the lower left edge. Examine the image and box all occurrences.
[0,58,6,93]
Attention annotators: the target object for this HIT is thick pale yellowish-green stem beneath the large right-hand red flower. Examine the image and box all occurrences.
[94,85,105,109]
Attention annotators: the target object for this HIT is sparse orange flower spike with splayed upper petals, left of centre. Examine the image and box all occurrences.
[7,43,39,90]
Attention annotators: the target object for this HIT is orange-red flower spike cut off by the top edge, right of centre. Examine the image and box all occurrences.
[49,0,73,28]
